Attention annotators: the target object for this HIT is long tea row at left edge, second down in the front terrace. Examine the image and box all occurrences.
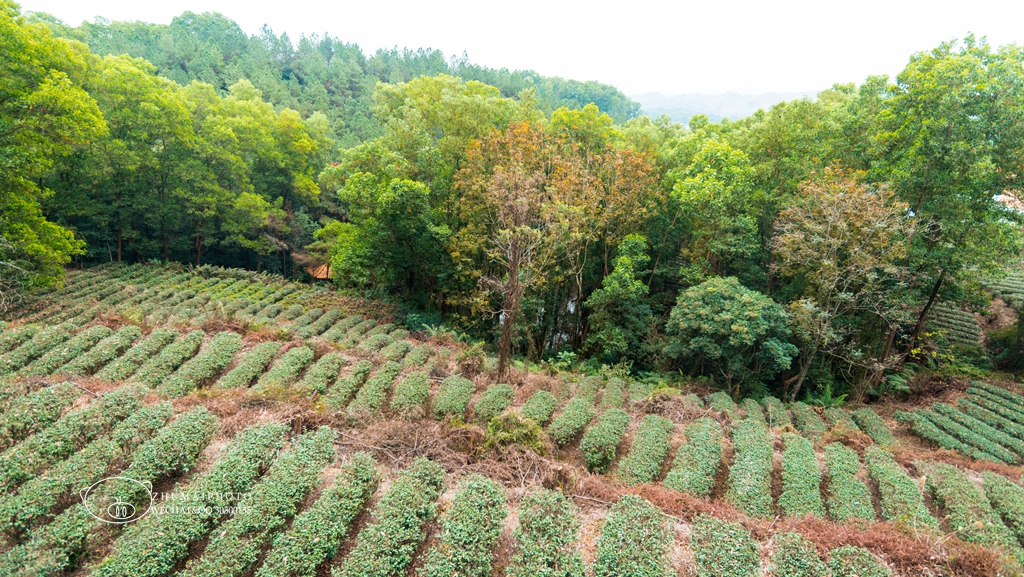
[0,386,143,491]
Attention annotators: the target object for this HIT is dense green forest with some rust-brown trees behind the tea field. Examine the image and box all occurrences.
[0,0,1024,401]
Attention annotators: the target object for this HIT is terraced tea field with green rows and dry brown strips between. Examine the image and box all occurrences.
[0,265,1024,577]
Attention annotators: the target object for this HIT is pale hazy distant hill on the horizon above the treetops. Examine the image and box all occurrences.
[630,91,817,124]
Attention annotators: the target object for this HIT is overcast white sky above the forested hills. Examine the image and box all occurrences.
[20,0,1024,94]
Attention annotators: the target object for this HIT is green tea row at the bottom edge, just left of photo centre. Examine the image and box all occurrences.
[419,475,508,577]
